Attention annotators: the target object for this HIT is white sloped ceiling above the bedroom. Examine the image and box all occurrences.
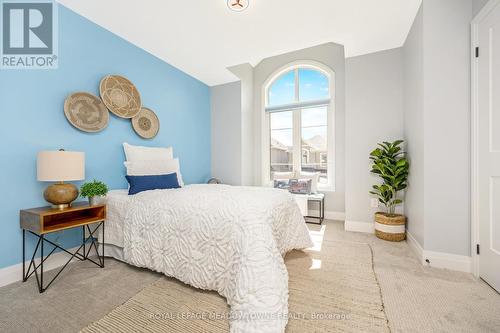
[58,0,421,86]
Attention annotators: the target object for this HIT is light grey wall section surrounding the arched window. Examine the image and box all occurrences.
[253,43,345,213]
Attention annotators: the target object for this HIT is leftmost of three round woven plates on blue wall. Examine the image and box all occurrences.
[64,92,109,132]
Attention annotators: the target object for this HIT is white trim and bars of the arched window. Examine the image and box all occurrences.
[261,60,336,192]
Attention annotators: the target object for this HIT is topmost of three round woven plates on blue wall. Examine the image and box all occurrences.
[99,75,141,118]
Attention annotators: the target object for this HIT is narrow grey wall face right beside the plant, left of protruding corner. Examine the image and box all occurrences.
[402,6,425,247]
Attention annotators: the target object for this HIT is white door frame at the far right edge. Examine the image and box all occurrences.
[470,0,500,278]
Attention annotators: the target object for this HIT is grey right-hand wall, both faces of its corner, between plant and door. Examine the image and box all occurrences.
[403,0,473,256]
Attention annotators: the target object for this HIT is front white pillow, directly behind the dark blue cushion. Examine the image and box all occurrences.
[123,158,184,187]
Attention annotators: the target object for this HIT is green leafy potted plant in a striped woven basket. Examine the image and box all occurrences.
[370,140,410,242]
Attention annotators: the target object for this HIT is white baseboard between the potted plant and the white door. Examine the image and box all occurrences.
[406,231,472,273]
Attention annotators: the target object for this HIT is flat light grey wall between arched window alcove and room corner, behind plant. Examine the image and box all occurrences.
[345,48,403,225]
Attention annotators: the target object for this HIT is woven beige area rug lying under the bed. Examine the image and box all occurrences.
[82,241,389,333]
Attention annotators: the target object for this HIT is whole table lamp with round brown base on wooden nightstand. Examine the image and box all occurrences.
[37,149,85,209]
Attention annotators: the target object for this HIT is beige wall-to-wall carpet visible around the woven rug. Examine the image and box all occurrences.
[0,221,500,333]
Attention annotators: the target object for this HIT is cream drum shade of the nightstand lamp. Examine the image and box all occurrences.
[36,151,85,182]
